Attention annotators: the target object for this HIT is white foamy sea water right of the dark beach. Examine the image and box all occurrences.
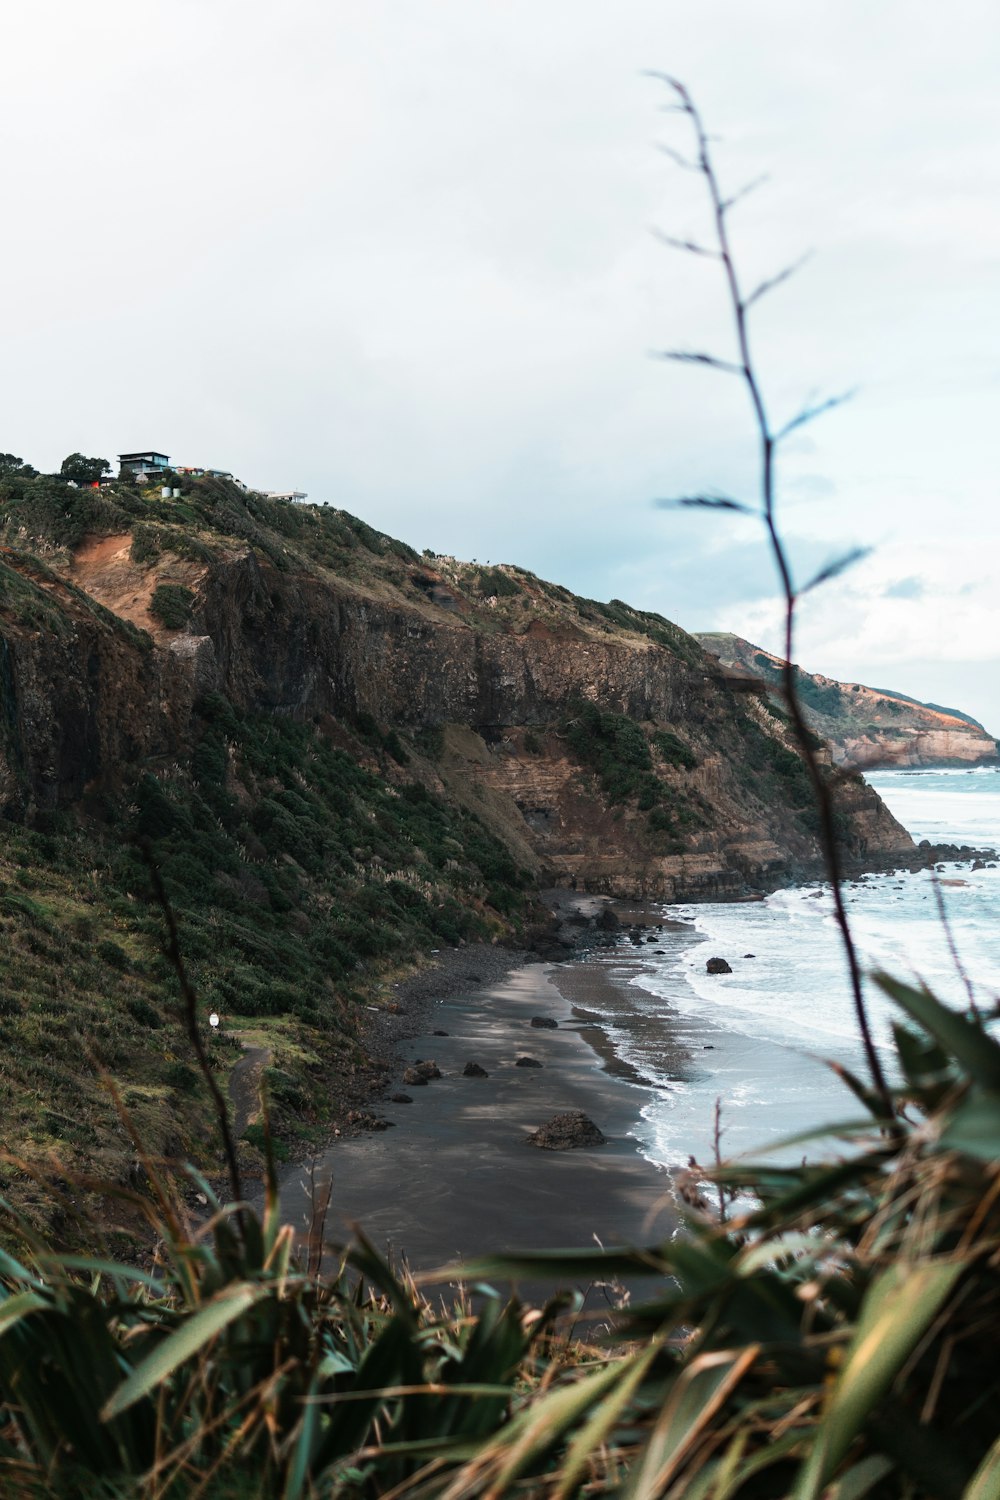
[587,768,1000,1166]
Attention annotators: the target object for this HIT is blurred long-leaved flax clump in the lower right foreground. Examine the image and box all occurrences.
[420,975,1000,1500]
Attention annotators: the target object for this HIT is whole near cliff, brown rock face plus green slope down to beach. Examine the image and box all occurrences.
[0,476,915,1218]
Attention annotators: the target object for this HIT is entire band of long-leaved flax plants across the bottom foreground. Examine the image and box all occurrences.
[0,975,1000,1500]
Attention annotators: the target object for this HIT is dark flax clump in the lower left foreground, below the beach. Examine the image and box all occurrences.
[0,1134,575,1500]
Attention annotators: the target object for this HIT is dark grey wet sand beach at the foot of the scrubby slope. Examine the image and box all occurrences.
[282,962,676,1295]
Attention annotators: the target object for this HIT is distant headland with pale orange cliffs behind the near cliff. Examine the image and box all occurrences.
[697,632,997,770]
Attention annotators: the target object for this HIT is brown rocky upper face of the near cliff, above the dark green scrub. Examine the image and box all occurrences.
[0,486,912,899]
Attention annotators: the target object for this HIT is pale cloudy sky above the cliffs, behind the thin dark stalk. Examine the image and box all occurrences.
[0,0,1000,734]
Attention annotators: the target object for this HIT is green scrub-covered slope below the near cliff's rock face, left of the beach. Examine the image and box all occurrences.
[0,696,531,1239]
